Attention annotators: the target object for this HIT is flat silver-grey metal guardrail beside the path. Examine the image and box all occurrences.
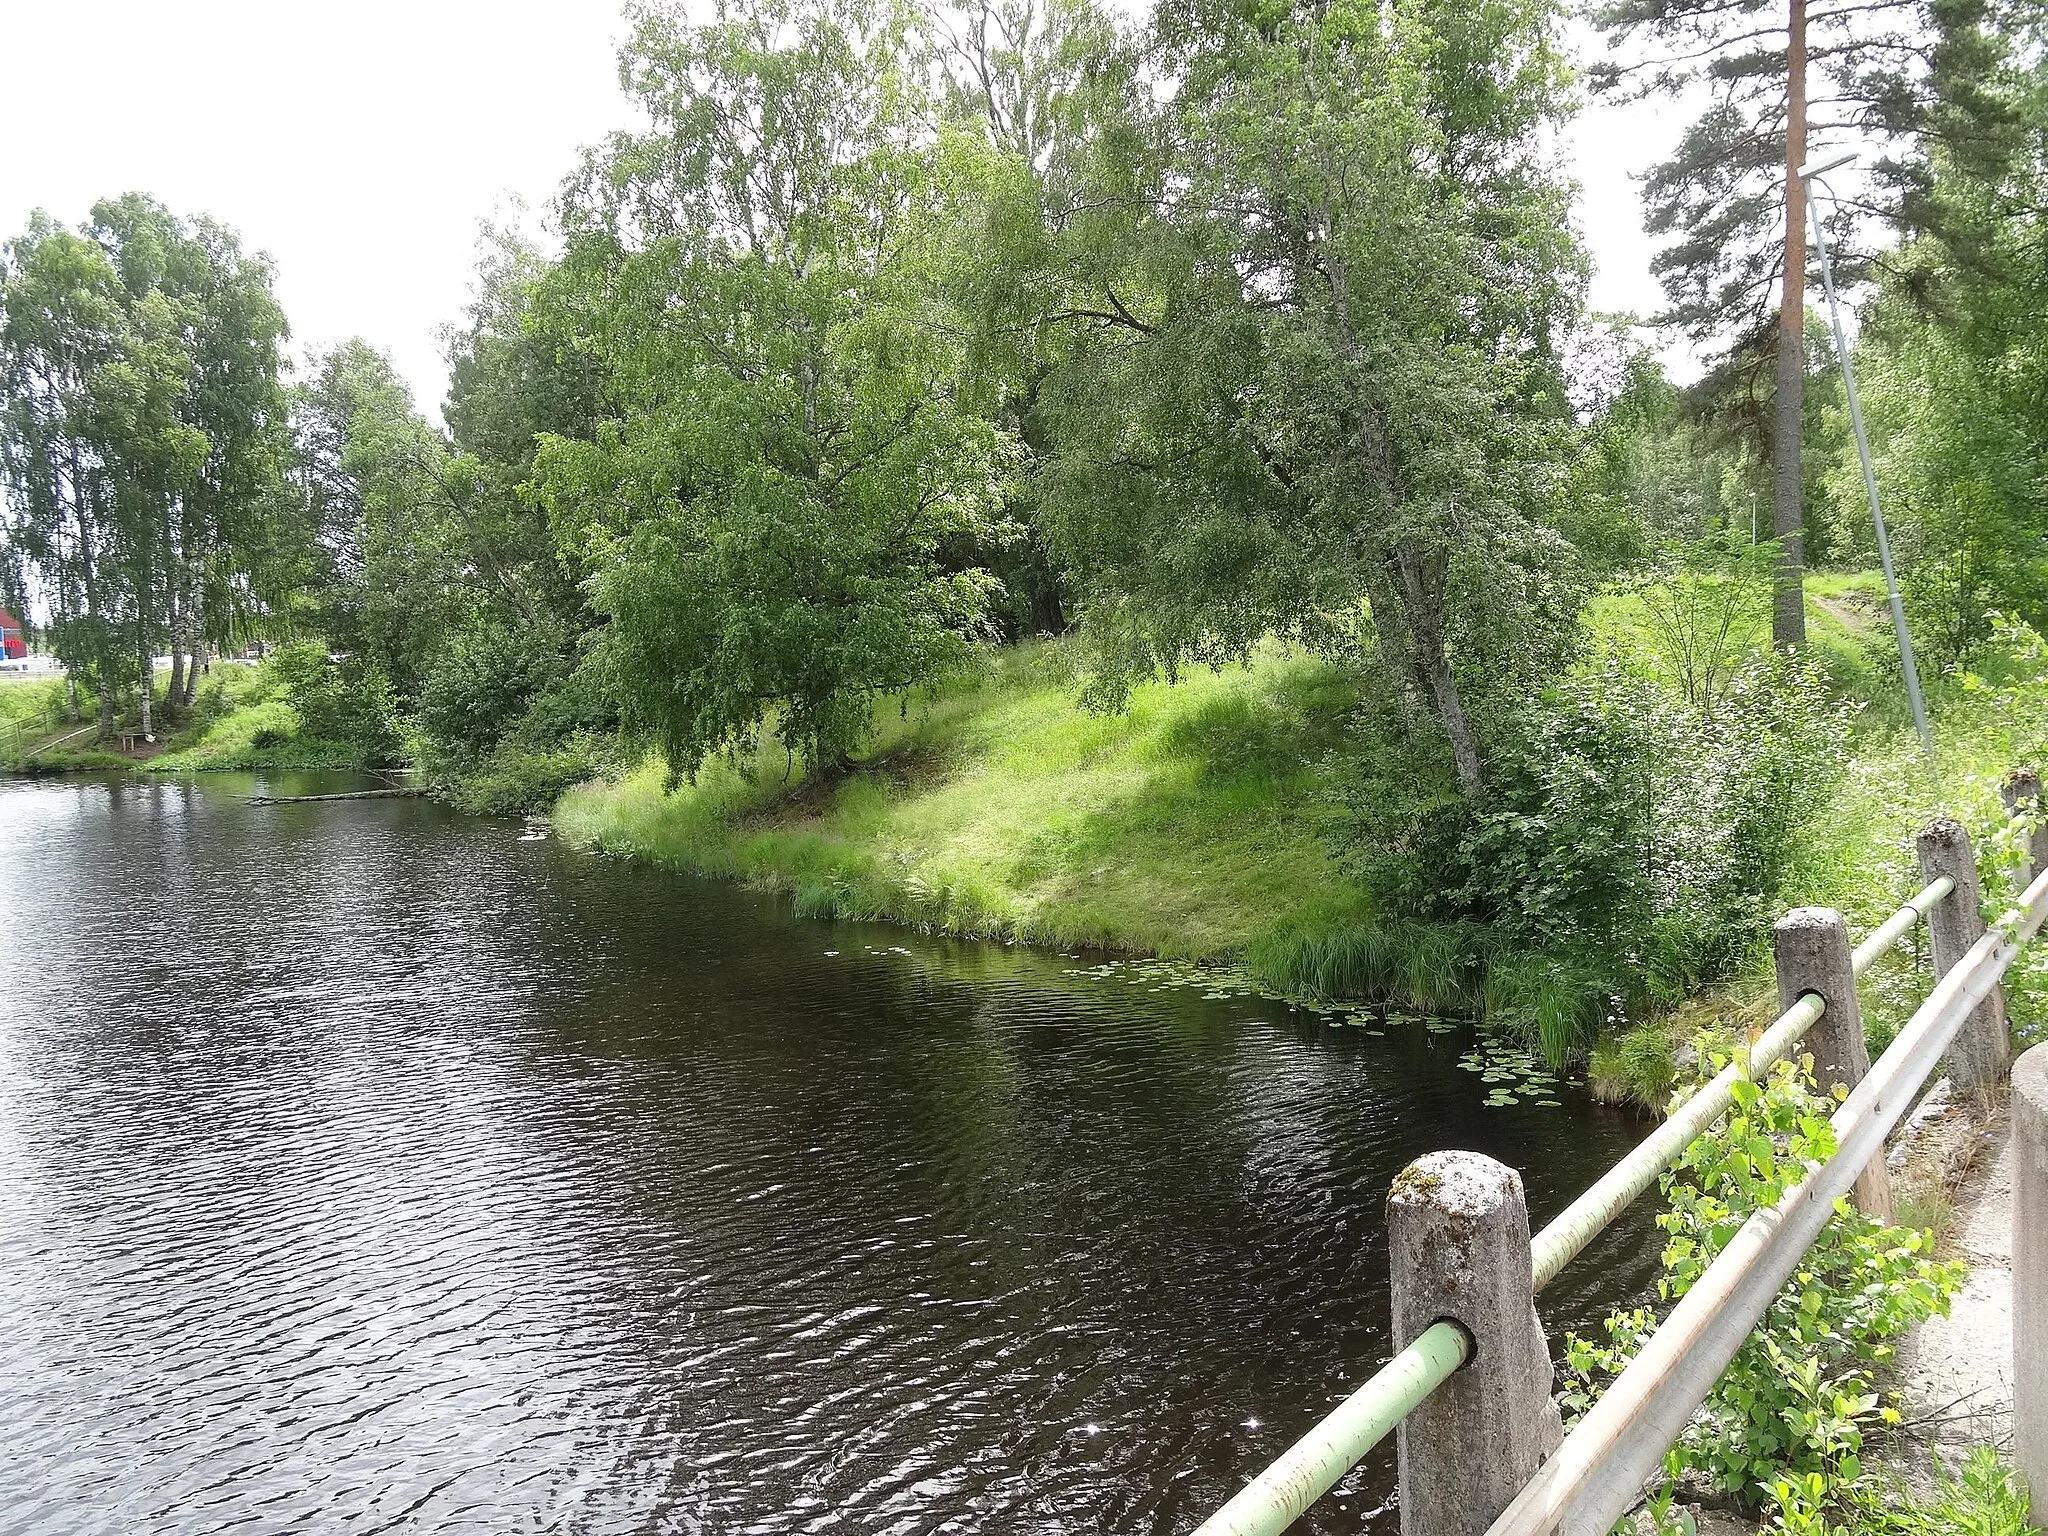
[1489,874,2048,1536]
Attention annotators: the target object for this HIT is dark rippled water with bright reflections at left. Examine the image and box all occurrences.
[0,780,1653,1534]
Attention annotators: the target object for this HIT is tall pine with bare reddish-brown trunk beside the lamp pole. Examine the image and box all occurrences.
[1591,0,1989,645]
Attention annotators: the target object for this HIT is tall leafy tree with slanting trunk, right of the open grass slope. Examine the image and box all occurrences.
[1014,0,1581,795]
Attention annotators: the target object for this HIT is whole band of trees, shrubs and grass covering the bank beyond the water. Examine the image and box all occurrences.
[0,0,2048,1532]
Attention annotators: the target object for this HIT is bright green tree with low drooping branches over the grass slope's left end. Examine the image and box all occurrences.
[537,0,1012,774]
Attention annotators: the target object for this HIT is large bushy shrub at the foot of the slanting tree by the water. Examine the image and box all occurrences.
[1343,657,1847,1061]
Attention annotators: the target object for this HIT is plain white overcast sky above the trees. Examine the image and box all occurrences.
[0,0,1679,412]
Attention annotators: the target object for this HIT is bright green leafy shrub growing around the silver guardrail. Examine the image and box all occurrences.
[1565,1053,1962,1509]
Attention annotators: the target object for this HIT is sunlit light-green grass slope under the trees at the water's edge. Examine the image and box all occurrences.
[555,643,1358,958]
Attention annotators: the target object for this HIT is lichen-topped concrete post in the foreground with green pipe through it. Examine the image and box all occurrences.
[1386,1151,1565,1536]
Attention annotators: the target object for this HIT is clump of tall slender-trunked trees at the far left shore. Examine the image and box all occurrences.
[0,195,285,735]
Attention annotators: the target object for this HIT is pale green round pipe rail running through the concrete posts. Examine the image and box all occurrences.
[1194,874,1956,1536]
